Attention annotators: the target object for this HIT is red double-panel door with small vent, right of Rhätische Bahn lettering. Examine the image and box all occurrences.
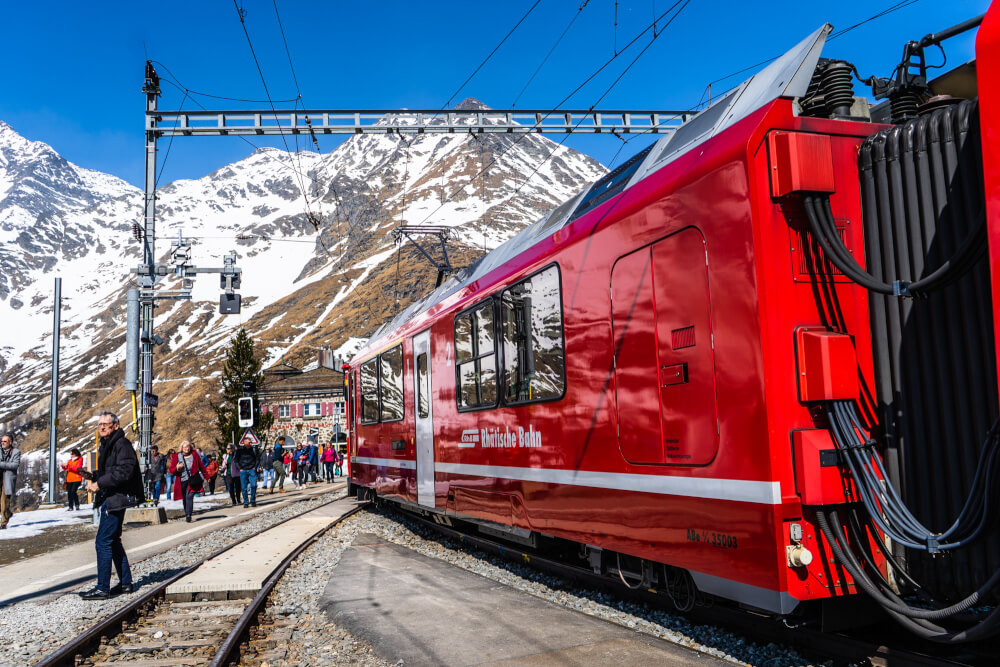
[611,227,719,465]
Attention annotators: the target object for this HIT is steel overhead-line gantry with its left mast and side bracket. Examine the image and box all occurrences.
[133,61,693,482]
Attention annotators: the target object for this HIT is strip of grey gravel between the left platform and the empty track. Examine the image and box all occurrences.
[0,489,344,667]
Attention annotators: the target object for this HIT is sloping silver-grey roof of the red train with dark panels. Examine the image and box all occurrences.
[362,23,833,352]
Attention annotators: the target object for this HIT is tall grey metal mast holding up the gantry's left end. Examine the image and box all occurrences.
[139,60,160,475]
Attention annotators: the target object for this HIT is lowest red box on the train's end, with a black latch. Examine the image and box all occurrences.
[792,429,850,505]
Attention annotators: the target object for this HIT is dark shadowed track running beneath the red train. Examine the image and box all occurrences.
[391,505,996,667]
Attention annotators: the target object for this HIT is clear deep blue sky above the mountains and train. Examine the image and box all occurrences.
[0,0,988,186]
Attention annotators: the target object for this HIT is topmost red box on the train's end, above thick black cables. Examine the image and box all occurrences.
[767,131,836,197]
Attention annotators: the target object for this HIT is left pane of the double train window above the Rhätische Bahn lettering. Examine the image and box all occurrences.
[455,299,497,410]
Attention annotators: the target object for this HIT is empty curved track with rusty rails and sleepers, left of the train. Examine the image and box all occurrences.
[38,497,364,667]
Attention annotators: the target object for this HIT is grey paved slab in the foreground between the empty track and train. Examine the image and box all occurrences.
[320,534,726,666]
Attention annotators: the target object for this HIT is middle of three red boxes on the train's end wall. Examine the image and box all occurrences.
[795,327,858,402]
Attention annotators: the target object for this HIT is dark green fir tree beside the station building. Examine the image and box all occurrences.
[215,328,274,449]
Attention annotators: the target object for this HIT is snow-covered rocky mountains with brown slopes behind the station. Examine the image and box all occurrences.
[0,100,605,460]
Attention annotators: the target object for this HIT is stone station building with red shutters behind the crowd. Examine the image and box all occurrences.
[258,349,347,446]
